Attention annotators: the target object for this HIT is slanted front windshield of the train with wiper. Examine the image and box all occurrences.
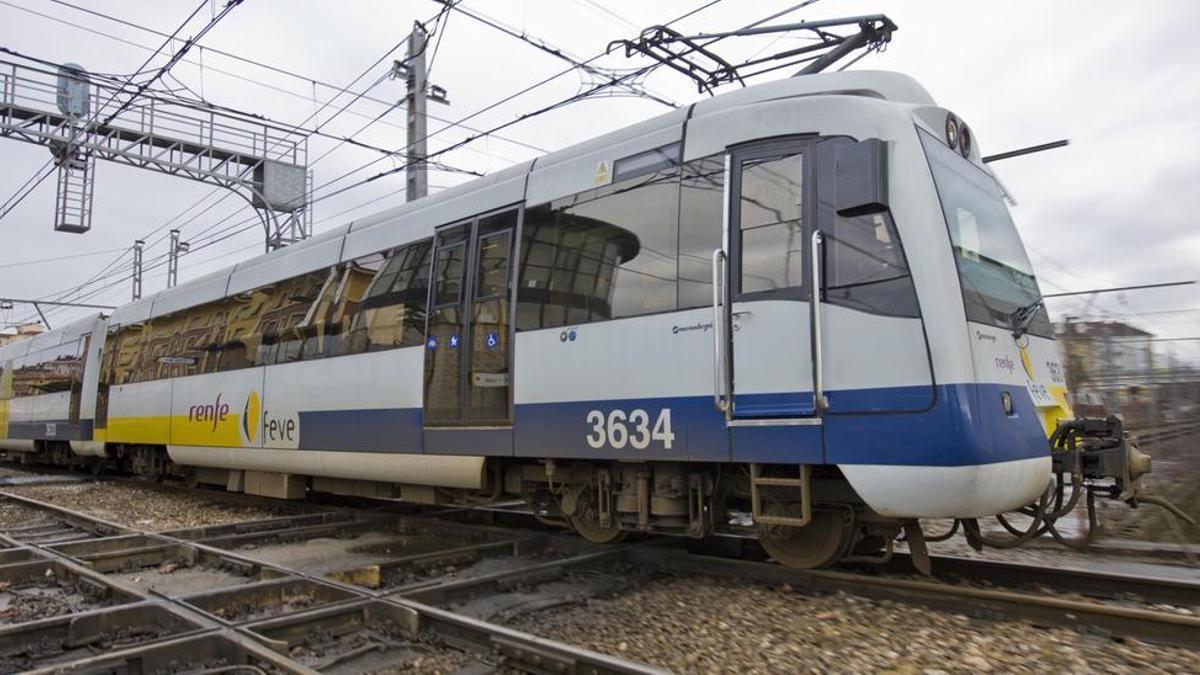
[920,131,1051,336]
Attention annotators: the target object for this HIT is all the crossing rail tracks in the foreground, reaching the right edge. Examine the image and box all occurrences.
[0,475,1200,673]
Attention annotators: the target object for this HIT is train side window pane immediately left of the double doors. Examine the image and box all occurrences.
[340,239,433,353]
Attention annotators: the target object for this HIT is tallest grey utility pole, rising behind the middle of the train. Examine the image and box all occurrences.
[391,22,449,202]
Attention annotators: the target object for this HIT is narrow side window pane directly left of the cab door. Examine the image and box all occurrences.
[679,154,725,309]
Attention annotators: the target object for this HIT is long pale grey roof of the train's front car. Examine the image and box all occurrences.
[110,71,936,325]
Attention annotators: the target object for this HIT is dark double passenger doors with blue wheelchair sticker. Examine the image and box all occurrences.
[424,209,520,454]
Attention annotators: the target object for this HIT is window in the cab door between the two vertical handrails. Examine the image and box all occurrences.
[738,154,806,293]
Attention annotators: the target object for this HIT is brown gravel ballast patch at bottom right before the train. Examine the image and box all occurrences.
[512,579,1200,675]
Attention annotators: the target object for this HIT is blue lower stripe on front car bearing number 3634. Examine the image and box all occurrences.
[290,384,1049,466]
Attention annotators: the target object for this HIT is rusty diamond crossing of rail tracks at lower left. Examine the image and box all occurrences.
[0,482,661,673]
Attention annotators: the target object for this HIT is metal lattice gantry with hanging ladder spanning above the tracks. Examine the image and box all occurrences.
[0,55,312,250]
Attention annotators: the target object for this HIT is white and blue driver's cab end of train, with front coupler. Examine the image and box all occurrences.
[688,73,1148,567]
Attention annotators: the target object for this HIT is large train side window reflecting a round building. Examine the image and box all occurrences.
[517,165,679,330]
